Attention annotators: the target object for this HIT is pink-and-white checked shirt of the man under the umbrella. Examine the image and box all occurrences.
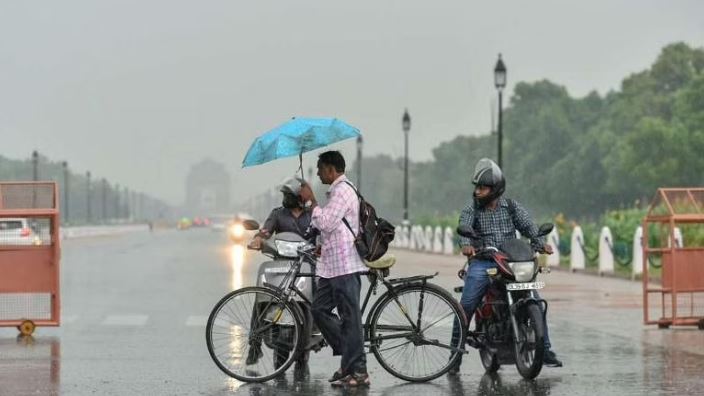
[311,175,367,278]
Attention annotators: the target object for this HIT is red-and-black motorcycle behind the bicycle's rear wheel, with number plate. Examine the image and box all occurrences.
[455,223,553,379]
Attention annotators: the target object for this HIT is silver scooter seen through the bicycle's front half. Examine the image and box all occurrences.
[243,220,319,368]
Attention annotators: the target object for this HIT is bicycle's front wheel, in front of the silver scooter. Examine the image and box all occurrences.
[205,287,303,382]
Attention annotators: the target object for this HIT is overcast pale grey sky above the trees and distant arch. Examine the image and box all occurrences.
[0,0,704,204]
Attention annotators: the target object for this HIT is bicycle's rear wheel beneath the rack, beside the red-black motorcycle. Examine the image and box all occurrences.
[370,283,465,382]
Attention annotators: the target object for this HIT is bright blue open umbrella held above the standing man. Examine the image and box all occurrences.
[242,118,361,168]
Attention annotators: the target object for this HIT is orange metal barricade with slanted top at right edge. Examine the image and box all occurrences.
[642,188,704,330]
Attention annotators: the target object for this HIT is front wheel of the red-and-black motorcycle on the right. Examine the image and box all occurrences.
[514,304,545,380]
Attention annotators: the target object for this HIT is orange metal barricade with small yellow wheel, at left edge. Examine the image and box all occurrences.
[0,182,61,335]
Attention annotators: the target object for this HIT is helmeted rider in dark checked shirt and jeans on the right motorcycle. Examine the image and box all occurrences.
[450,158,562,374]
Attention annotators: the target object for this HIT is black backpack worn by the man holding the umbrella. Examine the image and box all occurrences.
[342,182,396,261]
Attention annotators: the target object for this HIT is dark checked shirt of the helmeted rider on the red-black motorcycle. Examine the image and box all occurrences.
[459,197,545,250]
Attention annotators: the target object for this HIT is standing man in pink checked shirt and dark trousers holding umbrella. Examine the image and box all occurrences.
[301,151,369,386]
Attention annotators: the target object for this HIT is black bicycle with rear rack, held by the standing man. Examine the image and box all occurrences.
[206,240,467,382]
